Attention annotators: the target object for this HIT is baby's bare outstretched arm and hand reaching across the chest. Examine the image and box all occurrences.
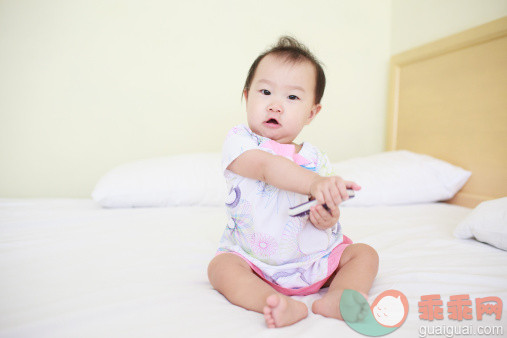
[227,149,361,210]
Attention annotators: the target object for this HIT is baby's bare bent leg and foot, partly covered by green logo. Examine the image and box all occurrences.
[312,244,378,320]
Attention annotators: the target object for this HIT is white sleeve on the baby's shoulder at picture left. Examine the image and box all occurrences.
[222,125,260,174]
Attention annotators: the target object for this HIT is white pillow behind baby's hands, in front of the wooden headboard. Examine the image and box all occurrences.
[333,150,471,206]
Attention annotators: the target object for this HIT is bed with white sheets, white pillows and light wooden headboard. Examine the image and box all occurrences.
[0,18,507,337]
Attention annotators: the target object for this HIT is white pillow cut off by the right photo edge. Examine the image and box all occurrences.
[454,197,507,250]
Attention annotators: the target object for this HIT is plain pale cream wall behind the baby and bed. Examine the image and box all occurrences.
[0,0,507,197]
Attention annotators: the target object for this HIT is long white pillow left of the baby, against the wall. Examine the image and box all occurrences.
[92,153,226,208]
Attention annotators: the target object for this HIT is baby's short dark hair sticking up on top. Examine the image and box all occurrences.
[243,36,326,104]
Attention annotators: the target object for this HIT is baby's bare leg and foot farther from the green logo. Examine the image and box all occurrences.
[208,253,308,328]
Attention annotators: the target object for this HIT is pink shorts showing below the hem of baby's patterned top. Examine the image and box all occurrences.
[217,235,352,296]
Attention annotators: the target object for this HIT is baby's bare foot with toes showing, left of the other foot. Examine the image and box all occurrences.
[264,294,308,328]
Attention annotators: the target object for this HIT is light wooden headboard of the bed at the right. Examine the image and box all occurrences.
[386,17,507,207]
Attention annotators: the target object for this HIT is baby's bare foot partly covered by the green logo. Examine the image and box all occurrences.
[312,290,370,321]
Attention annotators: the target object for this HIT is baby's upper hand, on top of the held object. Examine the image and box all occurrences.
[310,176,361,210]
